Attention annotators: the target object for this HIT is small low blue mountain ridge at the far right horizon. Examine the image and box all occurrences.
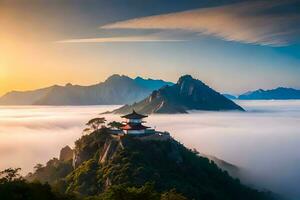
[238,87,300,100]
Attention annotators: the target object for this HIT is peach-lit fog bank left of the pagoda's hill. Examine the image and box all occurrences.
[0,106,116,175]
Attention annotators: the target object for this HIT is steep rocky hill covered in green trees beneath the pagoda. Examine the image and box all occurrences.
[21,122,275,200]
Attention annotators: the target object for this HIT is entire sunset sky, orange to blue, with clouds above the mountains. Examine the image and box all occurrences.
[0,0,300,95]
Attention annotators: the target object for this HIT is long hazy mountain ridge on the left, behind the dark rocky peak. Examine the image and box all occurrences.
[0,74,173,105]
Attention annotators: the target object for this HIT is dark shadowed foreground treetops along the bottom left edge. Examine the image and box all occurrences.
[0,168,187,200]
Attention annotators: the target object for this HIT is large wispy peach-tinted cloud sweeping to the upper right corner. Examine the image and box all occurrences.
[100,0,300,46]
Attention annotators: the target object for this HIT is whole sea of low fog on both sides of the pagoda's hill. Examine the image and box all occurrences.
[0,101,300,199]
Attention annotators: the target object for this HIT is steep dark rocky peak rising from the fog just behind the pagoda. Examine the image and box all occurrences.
[112,75,244,114]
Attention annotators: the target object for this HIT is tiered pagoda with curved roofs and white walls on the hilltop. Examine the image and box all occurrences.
[121,110,150,135]
